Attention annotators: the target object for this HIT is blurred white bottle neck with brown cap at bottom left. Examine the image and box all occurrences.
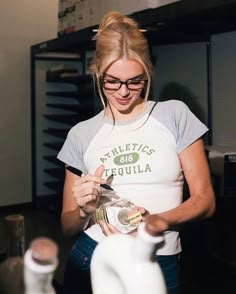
[24,238,58,294]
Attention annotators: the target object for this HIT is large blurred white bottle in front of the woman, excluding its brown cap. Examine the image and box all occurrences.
[91,223,167,294]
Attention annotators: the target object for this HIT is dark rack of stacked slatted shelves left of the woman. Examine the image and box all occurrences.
[32,51,98,214]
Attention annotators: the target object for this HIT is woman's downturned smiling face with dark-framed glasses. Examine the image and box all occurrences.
[100,59,146,119]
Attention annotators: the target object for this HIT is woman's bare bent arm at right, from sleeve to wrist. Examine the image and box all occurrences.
[149,139,215,228]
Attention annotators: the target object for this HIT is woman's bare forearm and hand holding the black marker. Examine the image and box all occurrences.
[61,166,106,235]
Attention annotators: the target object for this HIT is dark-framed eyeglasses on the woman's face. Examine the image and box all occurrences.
[99,75,147,91]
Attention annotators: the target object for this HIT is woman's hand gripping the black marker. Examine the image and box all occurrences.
[72,165,106,218]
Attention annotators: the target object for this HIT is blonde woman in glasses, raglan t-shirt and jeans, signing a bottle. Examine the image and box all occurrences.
[58,12,215,294]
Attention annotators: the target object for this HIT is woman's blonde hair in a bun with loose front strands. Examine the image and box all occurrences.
[91,11,152,106]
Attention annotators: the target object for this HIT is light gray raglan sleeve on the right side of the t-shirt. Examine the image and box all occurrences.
[157,100,208,153]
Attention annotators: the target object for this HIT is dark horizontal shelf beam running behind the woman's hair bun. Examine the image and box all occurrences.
[31,0,236,55]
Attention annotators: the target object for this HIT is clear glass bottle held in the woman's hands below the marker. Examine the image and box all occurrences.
[95,199,142,233]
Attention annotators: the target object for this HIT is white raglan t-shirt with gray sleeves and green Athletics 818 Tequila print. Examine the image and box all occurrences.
[58,100,208,255]
